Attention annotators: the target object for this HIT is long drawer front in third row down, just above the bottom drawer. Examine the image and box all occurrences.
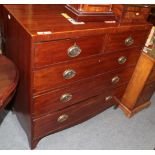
[33,67,134,117]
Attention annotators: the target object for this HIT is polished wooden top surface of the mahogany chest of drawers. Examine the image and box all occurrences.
[4,4,152,42]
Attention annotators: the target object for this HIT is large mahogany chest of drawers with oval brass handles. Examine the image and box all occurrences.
[2,5,151,148]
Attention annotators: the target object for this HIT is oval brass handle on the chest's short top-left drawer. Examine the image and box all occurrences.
[67,45,81,58]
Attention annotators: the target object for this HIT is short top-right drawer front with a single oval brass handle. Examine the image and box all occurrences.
[105,30,149,52]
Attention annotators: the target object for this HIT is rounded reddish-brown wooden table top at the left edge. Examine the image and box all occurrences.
[0,55,18,109]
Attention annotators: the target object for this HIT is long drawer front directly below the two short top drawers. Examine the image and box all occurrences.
[34,49,140,93]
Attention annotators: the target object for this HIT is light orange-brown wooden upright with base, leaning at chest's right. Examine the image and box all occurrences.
[119,52,155,117]
